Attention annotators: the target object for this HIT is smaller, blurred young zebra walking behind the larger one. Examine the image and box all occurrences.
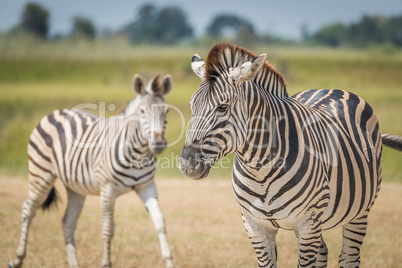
[9,75,174,267]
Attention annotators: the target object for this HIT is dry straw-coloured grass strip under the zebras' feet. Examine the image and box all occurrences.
[0,177,402,267]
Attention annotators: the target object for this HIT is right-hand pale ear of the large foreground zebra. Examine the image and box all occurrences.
[229,53,267,83]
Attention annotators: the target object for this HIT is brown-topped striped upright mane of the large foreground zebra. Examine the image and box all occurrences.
[205,42,288,97]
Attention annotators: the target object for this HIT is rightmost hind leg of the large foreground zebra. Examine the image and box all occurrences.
[339,212,368,267]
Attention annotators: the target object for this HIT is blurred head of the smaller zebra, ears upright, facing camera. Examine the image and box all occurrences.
[124,74,173,154]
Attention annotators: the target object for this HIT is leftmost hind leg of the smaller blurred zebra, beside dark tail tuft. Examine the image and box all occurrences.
[9,170,55,268]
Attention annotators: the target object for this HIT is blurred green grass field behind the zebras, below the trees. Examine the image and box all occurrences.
[0,38,402,181]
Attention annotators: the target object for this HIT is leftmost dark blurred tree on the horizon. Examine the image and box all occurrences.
[20,2,49,38]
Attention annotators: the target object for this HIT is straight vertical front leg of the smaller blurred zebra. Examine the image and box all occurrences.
[101,185,117,268]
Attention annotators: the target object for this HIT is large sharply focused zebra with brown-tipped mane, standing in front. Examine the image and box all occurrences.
[179,43,402,267]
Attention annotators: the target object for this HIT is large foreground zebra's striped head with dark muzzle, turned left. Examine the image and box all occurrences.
[179,45,266,179]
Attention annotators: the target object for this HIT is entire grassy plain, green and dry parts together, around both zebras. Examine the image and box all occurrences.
[0,38,402,267]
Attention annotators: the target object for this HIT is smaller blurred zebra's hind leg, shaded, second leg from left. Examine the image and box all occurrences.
[62,187,85,268]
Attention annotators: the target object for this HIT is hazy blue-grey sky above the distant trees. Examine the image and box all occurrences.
[0,0,402,38]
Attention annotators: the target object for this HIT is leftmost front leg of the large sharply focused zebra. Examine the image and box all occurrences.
[242,210,278,267]
